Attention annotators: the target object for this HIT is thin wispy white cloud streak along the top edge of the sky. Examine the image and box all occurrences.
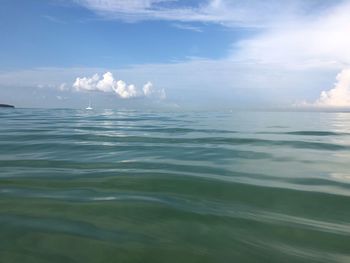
[72,0,332,28]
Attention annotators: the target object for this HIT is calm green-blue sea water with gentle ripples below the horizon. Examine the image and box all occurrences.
[0,109,350,263]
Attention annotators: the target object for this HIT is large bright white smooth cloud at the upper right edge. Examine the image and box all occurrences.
[231,1,350,69]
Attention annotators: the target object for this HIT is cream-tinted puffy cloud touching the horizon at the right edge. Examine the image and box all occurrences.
[314,69,350,107]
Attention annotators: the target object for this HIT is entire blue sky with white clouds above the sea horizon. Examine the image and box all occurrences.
[0,0,350,110]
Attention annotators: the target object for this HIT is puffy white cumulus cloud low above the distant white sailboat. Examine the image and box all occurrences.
[73,72,166,99]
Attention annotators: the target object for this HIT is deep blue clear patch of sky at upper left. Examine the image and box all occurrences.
[0,0,241,69]
